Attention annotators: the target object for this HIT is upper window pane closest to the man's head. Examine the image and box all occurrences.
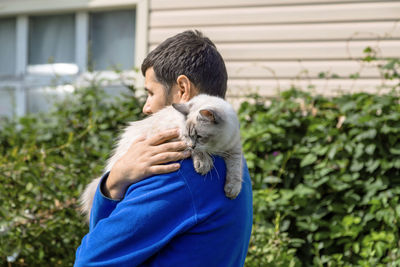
[89,10,135,70]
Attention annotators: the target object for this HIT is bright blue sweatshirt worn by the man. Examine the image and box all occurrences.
[75,157,252,267]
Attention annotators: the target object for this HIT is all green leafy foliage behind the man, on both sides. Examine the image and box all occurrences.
[0,58,400,267]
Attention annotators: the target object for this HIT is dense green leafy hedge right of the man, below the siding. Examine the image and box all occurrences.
[239,90,400,266]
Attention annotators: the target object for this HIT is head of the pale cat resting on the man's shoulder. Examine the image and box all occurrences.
[173,94,240,153]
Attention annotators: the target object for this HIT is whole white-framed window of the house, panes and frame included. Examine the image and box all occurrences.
[0,0,148,116]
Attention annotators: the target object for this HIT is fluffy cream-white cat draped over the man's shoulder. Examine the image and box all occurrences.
[81,94,242,220]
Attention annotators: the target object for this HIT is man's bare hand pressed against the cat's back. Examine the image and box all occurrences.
[102,129,190,199]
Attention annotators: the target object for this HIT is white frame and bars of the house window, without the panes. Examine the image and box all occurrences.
[0,0,149,116]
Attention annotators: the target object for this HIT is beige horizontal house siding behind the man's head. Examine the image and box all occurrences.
[149,0,400,98]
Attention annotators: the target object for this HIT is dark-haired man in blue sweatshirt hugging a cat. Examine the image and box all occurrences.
[75,31,252,267]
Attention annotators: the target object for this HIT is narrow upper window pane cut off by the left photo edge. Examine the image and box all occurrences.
[0,18,16,76]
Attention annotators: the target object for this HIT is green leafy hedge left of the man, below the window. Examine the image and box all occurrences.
[0,85,143,266]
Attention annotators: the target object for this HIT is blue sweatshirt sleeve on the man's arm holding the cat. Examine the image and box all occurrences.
[74,172,196,267]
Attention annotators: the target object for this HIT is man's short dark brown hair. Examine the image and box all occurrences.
[142,30,228,98]
